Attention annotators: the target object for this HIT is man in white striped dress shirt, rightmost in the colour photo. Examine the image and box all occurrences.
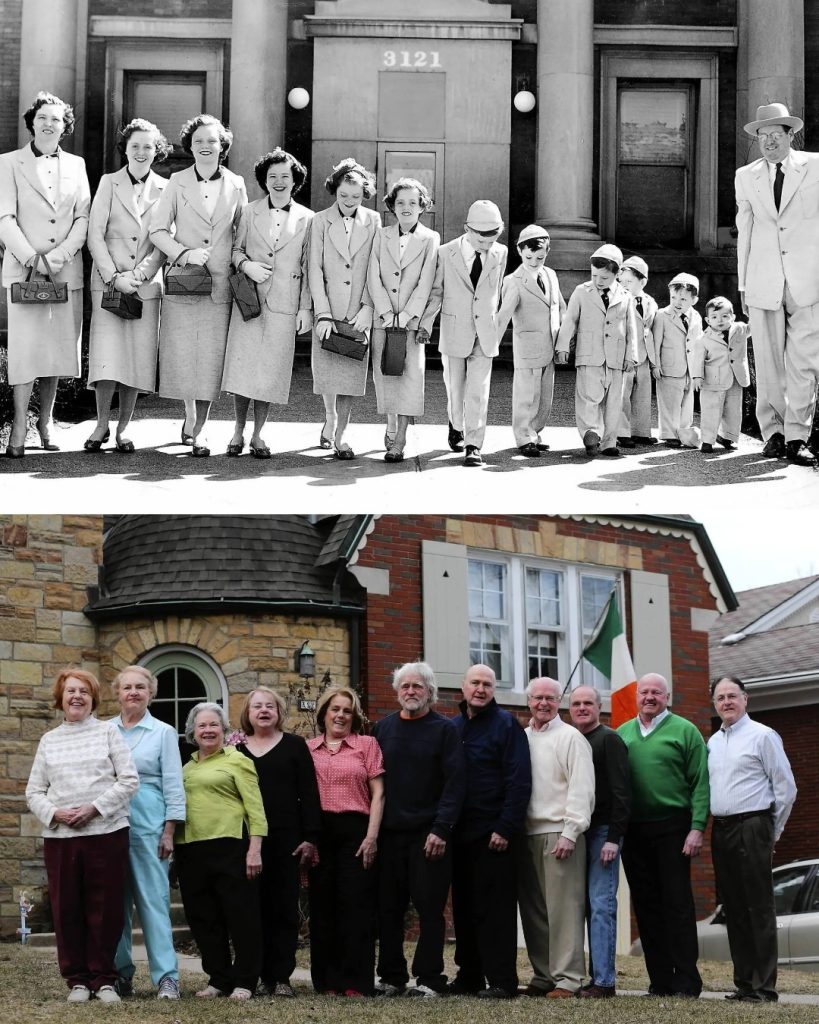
[708,676,796,1002]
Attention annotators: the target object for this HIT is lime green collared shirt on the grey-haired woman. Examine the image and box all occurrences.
[176,746,267,843]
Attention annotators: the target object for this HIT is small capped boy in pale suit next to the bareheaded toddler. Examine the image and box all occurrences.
[651,273,702,447]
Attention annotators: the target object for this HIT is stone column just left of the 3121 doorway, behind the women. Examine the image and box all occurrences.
[229,0,288,193]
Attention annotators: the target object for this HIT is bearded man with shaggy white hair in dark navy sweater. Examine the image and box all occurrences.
[373,662,466,998]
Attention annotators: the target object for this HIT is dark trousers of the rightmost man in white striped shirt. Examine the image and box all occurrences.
[710,812,778,999]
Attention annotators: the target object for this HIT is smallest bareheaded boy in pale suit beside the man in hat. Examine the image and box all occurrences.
[691,295,750,454]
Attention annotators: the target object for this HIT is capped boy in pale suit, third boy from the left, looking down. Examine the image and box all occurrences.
[555,244,637,458]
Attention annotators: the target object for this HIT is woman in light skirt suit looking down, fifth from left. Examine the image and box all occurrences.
[308,157,381,459]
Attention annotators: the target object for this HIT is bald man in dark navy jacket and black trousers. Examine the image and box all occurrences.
[449,665,531,999]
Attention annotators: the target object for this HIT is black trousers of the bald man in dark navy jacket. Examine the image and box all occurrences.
[452,835,518,992]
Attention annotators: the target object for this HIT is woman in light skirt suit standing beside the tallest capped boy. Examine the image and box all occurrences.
[368,178,441,462]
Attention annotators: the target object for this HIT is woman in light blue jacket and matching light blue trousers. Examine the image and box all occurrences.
[112,665,185,999]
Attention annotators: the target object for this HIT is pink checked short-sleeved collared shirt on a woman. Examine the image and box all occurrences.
[307,732,384,814]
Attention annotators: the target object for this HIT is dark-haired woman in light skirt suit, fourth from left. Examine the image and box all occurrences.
[222,148,313,459]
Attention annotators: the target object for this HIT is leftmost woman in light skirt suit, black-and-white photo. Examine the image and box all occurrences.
[0,92,91,459]
